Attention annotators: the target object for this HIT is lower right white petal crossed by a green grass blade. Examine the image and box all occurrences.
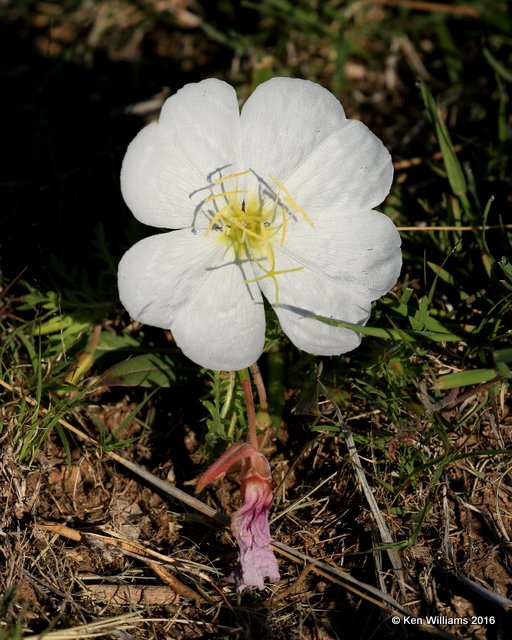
[254,211,402,355]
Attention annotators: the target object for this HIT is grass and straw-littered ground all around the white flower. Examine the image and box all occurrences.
[0,0,512,640]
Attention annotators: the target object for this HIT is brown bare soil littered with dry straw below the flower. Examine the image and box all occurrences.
[0,382,512,639]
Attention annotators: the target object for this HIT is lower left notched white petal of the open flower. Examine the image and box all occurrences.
[118,230,265,370]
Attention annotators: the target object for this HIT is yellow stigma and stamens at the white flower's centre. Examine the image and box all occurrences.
[202,169,314,306]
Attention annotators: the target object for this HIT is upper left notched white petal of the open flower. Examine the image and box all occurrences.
[121,79,241,229]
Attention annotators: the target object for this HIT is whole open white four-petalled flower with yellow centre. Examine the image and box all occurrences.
[119,78,401,370]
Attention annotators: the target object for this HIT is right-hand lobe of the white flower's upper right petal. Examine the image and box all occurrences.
[286,120,393,216]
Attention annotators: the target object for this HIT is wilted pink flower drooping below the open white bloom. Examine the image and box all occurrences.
[196,442,279,590]
